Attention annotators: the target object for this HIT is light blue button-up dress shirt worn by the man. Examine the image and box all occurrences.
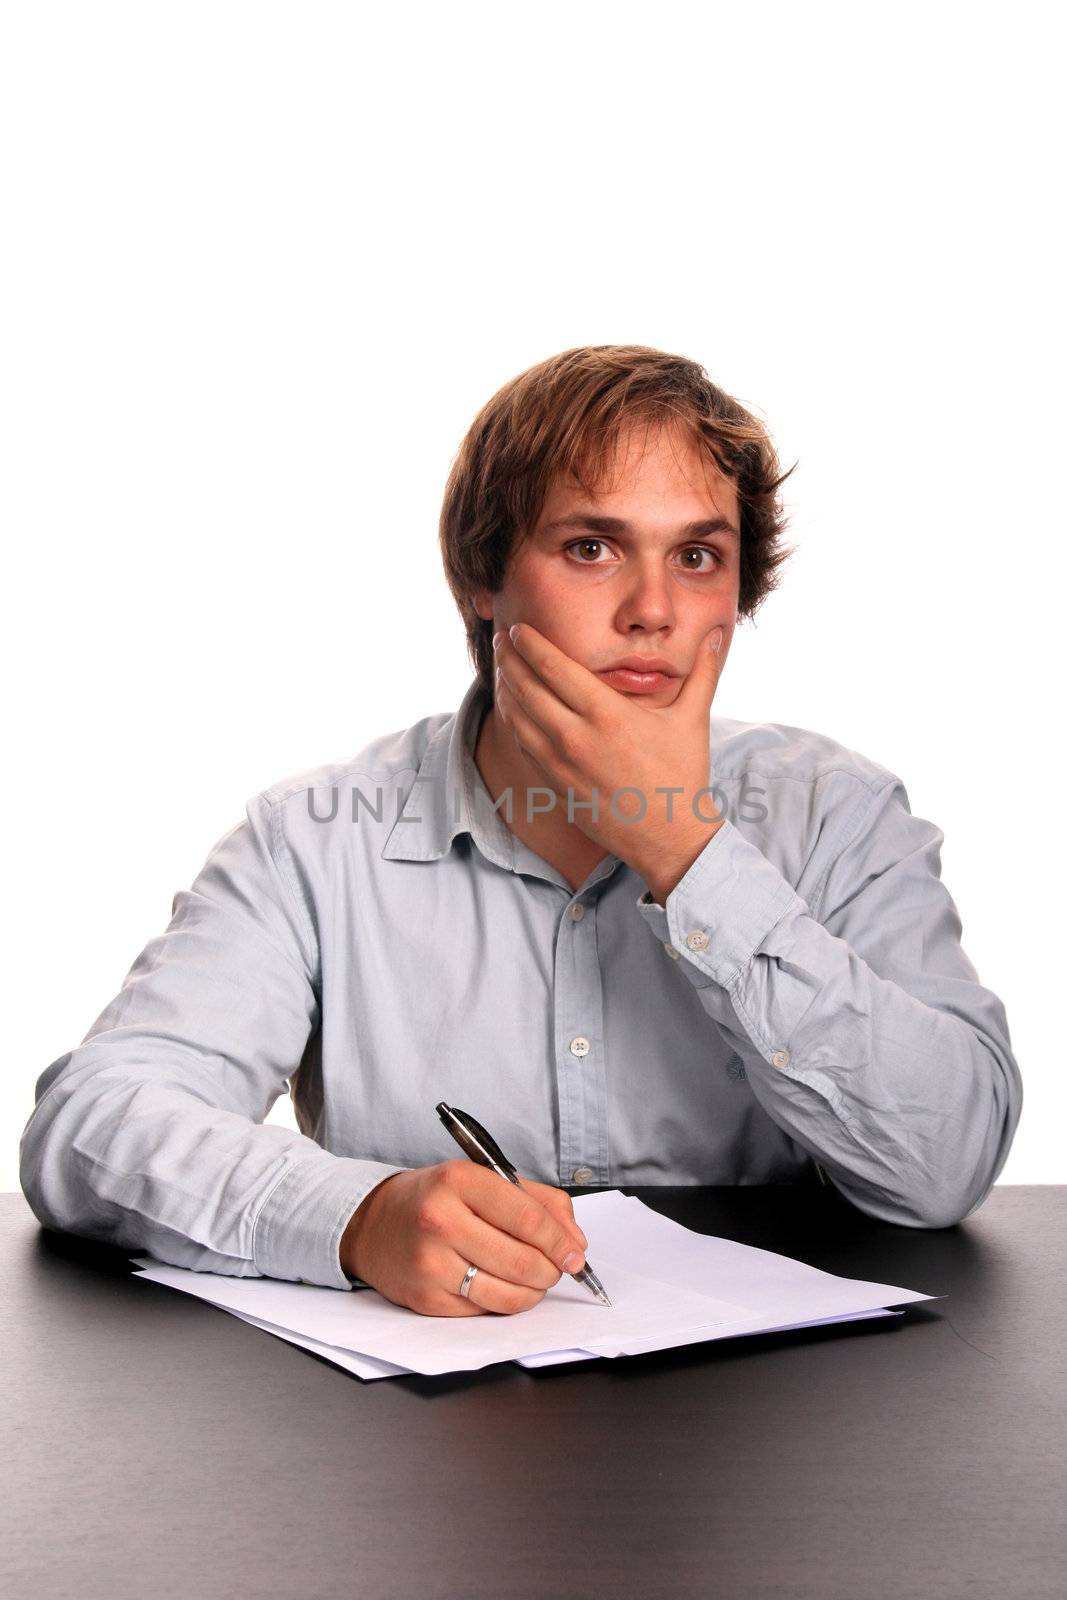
[21,680,1022,1290]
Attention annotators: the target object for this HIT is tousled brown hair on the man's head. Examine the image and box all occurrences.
[440,344,795,698]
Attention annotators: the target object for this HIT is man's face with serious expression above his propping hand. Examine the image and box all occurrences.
[474,426,739,706]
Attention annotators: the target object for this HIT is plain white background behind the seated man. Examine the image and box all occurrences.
[0,0,1067,1189]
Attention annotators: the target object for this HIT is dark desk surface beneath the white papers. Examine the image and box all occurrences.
[0,1186,1067,1600]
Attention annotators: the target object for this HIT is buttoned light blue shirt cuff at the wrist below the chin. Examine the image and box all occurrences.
[637,818,808,989]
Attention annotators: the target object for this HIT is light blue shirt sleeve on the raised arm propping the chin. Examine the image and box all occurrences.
[638,774,1022,1227]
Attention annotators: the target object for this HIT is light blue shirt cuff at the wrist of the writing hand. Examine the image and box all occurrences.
[253,1150,405,1290]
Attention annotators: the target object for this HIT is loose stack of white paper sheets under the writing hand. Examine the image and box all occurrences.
[134,1190,939,1378]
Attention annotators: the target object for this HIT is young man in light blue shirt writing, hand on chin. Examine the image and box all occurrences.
[21,346,1022,1315]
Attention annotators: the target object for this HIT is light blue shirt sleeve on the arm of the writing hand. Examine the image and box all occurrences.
[19,795,400,1290]
